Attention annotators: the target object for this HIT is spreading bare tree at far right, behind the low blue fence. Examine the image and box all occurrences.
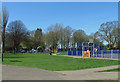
[96,21,118,48]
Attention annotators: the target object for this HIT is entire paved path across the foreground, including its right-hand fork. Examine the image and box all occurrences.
[2,65,118,80]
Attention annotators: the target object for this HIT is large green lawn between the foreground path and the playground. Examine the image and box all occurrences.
[3,53,118,71]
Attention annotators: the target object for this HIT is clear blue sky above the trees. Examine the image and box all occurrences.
[2,2,118,35]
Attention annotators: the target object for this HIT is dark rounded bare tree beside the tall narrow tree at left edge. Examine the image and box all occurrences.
[7,20,27,53]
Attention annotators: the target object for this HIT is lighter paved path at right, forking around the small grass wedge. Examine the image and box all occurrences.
[56,65,120,80]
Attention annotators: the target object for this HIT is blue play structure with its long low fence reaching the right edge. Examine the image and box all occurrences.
[68,42,120,59]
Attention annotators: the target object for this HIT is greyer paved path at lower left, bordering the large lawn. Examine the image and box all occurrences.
[2,65,63,80]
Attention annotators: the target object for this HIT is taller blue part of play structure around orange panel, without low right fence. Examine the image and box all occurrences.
[68,42,100,57]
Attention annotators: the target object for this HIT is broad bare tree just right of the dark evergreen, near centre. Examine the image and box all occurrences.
[45,24,63,49]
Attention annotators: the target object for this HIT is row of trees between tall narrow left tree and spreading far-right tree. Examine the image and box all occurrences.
[5,20,90,51]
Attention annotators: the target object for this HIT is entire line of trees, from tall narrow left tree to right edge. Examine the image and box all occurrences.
[2,8,120,53]
